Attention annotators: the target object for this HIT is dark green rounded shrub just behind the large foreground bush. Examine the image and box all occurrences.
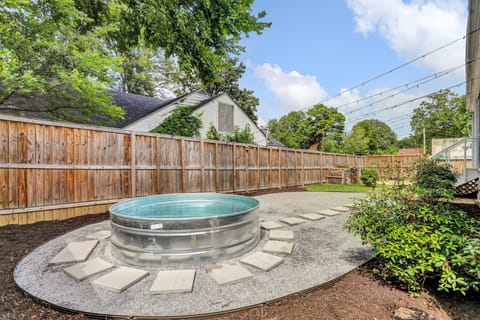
[415,159,457,199]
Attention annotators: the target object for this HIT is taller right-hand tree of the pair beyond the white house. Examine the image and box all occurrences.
[299,104,345,151]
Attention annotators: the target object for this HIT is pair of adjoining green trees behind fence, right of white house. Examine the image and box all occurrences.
[267,104,345,152]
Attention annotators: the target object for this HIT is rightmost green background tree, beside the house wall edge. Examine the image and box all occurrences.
[410,90,471,152]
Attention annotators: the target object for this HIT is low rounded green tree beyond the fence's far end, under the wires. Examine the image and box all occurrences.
[343,119,397,155]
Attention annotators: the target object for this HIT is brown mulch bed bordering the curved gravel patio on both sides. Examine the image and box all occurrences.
[0,188,480,320]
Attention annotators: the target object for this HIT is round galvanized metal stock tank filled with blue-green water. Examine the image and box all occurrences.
[110,193,260,265]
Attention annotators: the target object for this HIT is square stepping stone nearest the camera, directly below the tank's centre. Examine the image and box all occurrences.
[150,270,195,294]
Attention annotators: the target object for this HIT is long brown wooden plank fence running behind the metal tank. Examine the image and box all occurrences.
[0,115,415,225]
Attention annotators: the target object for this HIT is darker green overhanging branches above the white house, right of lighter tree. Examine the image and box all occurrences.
[116,0,270,83]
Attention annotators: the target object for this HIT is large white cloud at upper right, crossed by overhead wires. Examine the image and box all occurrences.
[348,0,467,71]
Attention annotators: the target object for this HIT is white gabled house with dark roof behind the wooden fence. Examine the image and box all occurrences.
[113,89,271,146]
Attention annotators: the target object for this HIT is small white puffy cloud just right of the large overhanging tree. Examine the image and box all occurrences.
[254,63,327,112]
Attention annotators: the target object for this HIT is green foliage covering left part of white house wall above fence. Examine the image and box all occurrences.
[152,106,202,137]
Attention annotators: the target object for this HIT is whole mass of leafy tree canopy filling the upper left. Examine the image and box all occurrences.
[0,0,270,123]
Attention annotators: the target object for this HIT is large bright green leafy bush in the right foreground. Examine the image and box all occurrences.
[346,160,480,294]
